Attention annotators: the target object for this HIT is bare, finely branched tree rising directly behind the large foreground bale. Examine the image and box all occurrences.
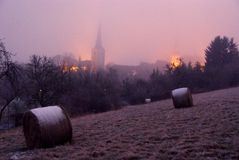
[26,55,64,106]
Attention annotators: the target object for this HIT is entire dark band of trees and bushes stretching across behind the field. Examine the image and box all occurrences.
[0,36,239,122]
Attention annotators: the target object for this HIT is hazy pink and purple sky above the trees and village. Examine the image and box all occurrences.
[0,0,239,64]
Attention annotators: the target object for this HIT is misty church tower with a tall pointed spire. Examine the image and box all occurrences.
[91,27,105,71]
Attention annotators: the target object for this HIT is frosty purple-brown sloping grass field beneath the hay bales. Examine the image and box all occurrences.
[0,88,239,160]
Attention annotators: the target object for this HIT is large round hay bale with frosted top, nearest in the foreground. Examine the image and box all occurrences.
[23,106,72,149]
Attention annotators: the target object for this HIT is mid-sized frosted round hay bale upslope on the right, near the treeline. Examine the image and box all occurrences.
[172,88,193,108]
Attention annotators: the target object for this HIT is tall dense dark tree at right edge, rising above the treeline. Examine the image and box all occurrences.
[205,36,239,89]
